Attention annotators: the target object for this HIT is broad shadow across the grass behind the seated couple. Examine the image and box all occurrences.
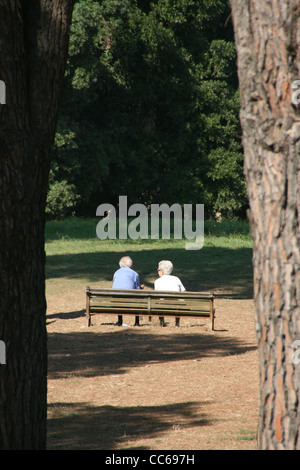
[46,246,253,299]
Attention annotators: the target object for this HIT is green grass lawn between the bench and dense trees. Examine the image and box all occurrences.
[45,217,252,298]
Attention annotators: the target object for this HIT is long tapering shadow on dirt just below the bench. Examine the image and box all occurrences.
[48,328,256,379]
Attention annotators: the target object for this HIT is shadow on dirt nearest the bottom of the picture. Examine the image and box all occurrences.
[48,402,210,450]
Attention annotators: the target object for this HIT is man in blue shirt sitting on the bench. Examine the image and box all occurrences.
[112,256,144,326]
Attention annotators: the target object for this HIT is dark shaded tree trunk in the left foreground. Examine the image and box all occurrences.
[0,0,73,449]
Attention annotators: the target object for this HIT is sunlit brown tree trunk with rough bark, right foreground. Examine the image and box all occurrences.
[231,0,300,449]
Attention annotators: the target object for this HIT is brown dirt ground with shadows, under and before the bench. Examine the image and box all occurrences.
[47,286,258,450]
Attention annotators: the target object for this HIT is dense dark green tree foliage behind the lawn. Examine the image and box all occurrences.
[47,0,247,217]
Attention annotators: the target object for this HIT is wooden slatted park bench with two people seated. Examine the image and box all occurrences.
[86,286,215,330]
